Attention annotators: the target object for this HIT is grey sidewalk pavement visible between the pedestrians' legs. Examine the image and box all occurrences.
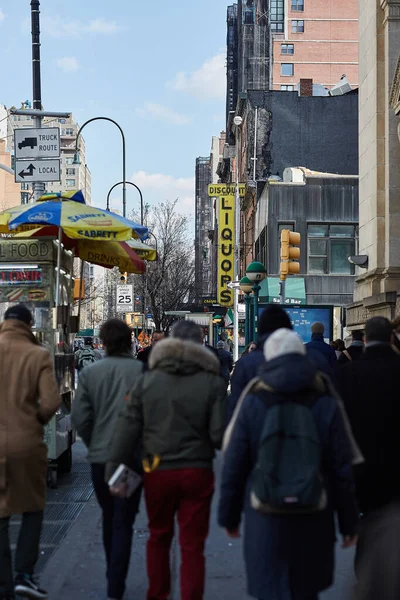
[41,460,247,600]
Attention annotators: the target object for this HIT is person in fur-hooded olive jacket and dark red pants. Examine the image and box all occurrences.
[109,321,226,600]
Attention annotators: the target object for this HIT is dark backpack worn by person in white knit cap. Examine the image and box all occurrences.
[251,390,327,515]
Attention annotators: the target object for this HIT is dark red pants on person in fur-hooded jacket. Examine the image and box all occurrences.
[144,469,214,600]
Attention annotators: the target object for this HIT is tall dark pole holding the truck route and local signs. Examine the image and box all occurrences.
[31,0,46,202]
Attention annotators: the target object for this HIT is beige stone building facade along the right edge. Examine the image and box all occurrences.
[347,0,400,328]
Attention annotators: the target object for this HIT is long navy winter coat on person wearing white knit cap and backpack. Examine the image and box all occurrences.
[218,355,358,600]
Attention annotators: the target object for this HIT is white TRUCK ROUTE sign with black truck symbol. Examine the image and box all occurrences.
[14,127,60,159]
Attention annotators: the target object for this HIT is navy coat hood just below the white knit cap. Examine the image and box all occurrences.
[260,354,317,395]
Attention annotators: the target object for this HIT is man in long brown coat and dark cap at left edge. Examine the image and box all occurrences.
[0,304,60,600]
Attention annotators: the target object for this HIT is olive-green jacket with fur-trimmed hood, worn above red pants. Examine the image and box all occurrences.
[109,338,226,470]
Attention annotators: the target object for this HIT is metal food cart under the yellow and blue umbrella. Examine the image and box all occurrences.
[0,238,76,487]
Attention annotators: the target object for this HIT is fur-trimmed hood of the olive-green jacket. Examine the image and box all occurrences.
[149,338,220,375]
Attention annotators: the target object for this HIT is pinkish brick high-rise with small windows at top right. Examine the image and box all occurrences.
[271,0,358,91]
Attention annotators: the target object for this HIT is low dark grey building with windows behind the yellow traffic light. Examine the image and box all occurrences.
[255,168,358,307]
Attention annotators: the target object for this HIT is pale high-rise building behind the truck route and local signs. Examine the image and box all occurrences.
[7,110,91,204]
